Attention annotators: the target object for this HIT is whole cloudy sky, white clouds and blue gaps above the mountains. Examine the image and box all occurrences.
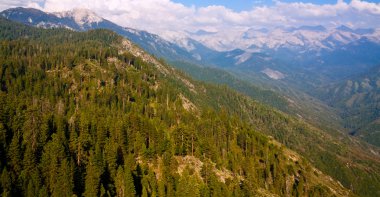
[0,0,380,37]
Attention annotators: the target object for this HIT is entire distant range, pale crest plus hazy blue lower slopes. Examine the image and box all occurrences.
[181,26,380,85]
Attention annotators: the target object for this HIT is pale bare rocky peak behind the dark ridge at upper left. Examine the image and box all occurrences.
[54,8,103,26]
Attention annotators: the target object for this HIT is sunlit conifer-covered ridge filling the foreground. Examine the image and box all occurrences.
[0,19,378,196]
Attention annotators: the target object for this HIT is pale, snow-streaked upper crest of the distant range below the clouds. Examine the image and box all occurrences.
[178,26,380,52]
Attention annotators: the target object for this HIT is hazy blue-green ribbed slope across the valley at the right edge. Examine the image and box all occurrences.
[319,66,380,146]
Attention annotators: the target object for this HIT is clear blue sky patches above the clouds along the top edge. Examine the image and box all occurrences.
[173,0,380,12]
